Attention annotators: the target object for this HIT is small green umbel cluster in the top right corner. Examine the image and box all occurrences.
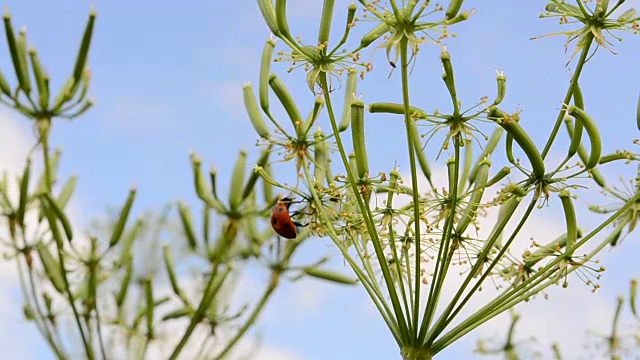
[533,0,640,65]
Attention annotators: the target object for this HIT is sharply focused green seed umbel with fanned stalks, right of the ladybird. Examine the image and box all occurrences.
[249,0,640,359]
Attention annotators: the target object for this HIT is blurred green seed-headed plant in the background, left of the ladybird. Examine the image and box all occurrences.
[0,5,354,359]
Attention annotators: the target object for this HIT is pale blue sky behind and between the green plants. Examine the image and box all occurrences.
[0,0,640,360]
